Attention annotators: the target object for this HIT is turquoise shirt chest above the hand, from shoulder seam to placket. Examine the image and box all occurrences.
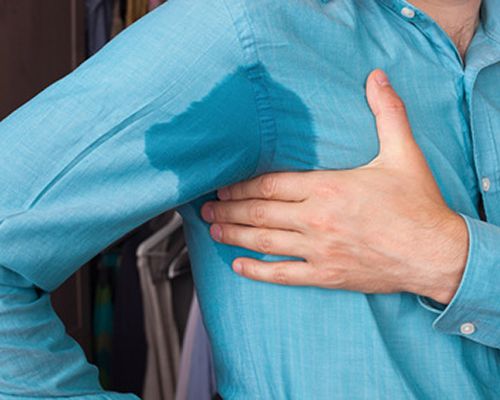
[249,0,500,220]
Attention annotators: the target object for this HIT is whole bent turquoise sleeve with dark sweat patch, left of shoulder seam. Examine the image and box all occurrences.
[0,0,261,400]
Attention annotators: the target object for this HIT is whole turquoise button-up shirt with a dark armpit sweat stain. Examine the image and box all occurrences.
[0,0,500,400]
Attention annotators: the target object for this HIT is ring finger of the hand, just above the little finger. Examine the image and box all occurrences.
[210,224,308,258]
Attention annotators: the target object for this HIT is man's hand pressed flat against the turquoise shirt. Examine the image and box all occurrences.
[202,70,468,304]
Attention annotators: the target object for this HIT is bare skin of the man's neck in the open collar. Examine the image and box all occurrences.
[408,0,481,58]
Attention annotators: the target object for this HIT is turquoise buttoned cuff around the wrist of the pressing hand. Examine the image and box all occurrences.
[418,214,500,348]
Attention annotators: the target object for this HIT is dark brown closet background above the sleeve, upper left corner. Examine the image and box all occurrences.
[0,0,148,119]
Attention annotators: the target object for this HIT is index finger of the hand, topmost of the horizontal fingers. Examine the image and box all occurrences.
[218,172,308,201]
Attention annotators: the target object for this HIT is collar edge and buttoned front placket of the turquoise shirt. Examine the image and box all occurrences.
[380,0,500,224]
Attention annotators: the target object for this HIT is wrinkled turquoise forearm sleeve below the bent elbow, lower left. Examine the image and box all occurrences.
[0,266,136,400]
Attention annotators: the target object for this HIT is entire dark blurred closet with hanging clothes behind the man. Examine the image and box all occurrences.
[0,0,215,400]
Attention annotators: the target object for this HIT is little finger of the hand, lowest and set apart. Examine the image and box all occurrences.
[233,258,317,286]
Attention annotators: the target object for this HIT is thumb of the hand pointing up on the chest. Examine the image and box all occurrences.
[366,69,421,162]
